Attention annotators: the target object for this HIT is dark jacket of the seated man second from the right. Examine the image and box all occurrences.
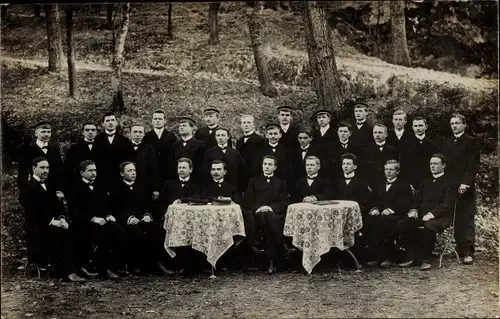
[373,178,413,216]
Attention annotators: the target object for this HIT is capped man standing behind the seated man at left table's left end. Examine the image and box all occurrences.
[169,116,206,182]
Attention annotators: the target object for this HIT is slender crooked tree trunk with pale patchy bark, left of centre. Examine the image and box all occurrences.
[111,2,130,111]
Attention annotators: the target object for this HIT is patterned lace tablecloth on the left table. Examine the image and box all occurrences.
[163,204,245,267]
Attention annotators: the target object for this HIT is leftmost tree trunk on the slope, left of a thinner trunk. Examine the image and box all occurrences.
[45,4,63,72]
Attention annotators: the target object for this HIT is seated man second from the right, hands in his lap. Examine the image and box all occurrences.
[363,160,413,267]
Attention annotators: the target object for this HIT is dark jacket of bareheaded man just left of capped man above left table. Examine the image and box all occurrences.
[142,129,177,184]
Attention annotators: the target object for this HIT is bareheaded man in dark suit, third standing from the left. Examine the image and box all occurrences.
[93,112,130,189]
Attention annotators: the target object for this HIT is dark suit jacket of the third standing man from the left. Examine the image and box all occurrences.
[93,132,130,187]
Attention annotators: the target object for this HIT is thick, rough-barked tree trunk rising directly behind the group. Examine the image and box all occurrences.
[300,1,342,111]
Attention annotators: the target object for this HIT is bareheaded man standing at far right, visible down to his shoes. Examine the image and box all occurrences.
[441,113,480,264]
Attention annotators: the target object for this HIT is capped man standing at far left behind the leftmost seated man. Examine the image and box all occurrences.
[17,121,65,198]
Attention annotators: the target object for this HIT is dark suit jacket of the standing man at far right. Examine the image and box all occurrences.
[441,133,480,188]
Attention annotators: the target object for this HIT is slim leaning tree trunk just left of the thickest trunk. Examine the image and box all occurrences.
[247,1,278,97]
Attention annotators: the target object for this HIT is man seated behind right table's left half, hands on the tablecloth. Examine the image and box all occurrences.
[291,156,333,203]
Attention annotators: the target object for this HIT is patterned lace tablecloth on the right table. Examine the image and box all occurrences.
[283,201,363,273]
